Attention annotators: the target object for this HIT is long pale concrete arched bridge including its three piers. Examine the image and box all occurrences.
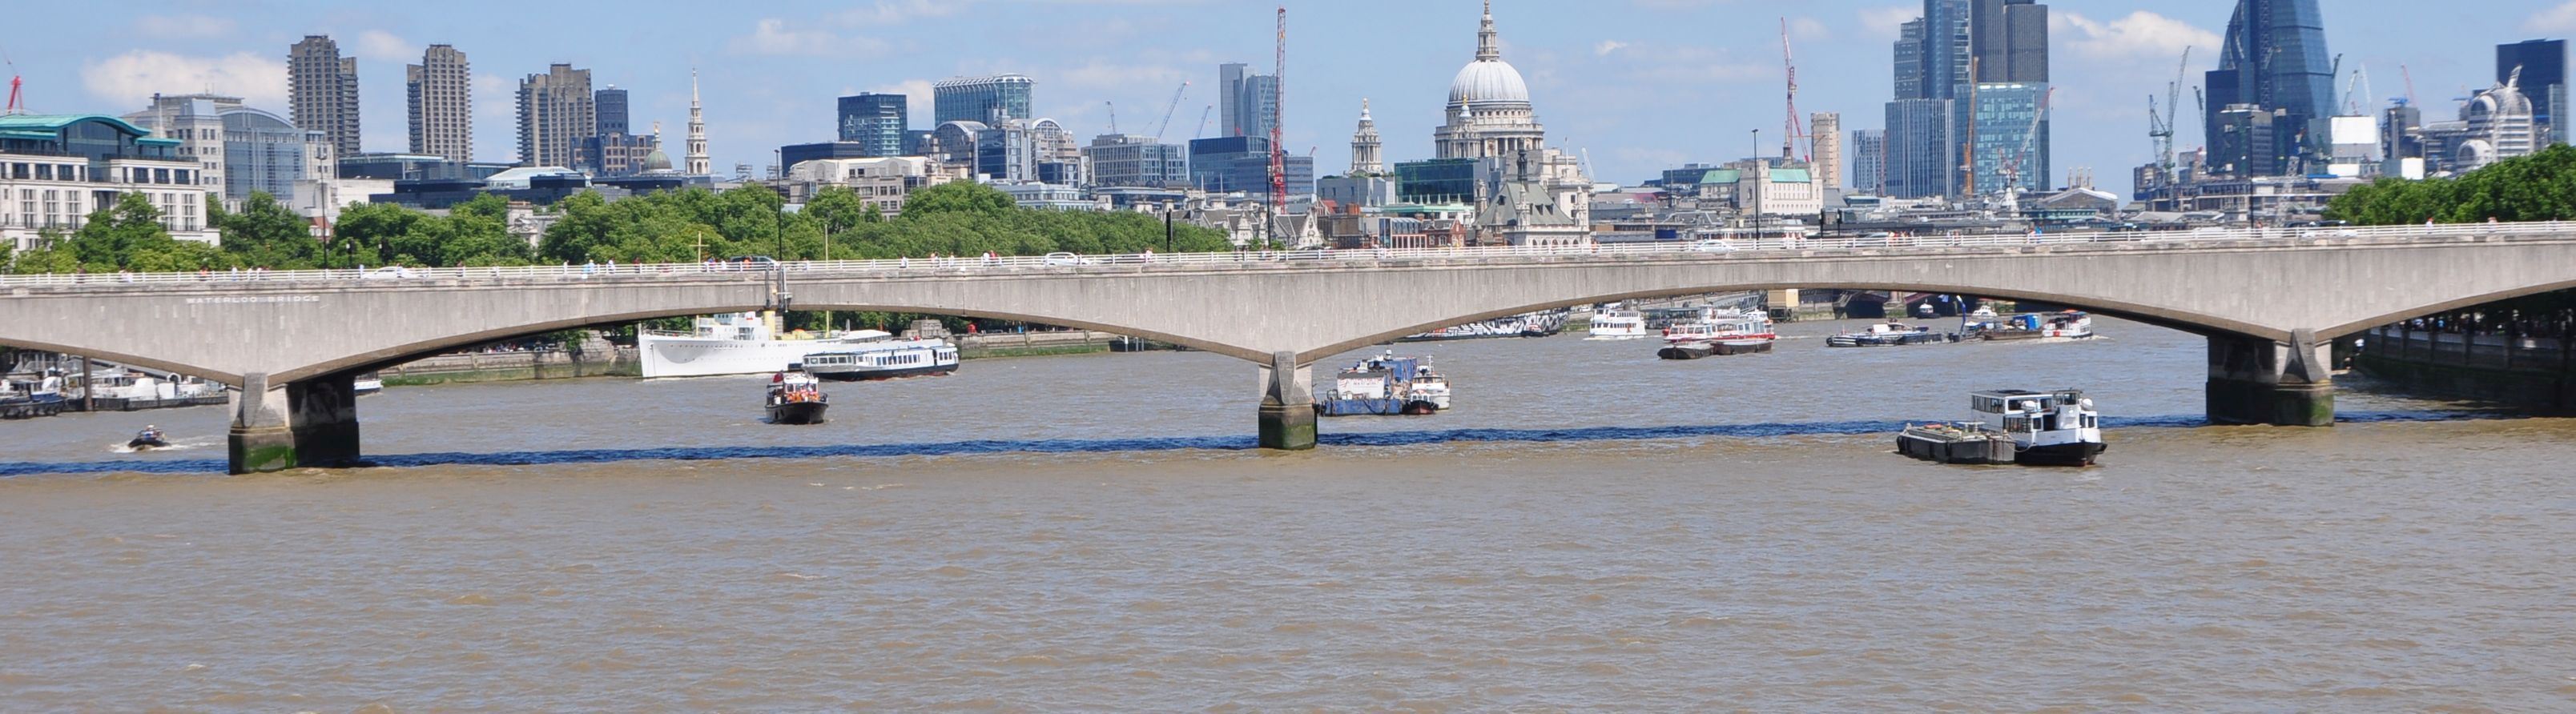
[0,222,2576,471]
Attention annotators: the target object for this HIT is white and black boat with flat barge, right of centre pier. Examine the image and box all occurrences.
[1896,389,2107,467]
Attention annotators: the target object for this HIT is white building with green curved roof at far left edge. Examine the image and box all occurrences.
[0,114,219,250]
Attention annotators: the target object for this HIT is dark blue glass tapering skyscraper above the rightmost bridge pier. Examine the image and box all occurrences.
[2203,0,2337,178]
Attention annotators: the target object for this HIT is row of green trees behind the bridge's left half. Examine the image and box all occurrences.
[0,183,1231,273]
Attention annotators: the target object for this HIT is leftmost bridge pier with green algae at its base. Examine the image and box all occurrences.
[224,371,358,475]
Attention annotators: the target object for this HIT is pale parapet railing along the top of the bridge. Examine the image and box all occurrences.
[0,222,2576,289]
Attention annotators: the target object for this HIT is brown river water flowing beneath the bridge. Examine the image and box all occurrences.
[0,319,2576,712]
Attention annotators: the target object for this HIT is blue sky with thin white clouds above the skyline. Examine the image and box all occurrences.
[20,0,2576,191]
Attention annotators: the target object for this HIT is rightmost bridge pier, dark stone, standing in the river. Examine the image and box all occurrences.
[2208,330,2334,425]
